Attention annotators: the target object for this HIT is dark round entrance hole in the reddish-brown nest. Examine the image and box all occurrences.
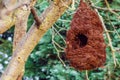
[76,33,88,47]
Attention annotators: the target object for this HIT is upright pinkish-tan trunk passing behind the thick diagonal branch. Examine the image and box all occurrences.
[13,5,30,80]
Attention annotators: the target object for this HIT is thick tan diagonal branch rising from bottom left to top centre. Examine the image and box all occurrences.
[1,0,71,80]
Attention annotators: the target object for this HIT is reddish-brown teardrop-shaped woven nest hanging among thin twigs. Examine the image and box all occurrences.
[66,0,106,70]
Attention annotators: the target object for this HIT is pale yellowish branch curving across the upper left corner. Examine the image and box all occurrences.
[0,0,30,34]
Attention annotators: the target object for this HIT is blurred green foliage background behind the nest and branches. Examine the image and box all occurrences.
[0,0,120,80]
